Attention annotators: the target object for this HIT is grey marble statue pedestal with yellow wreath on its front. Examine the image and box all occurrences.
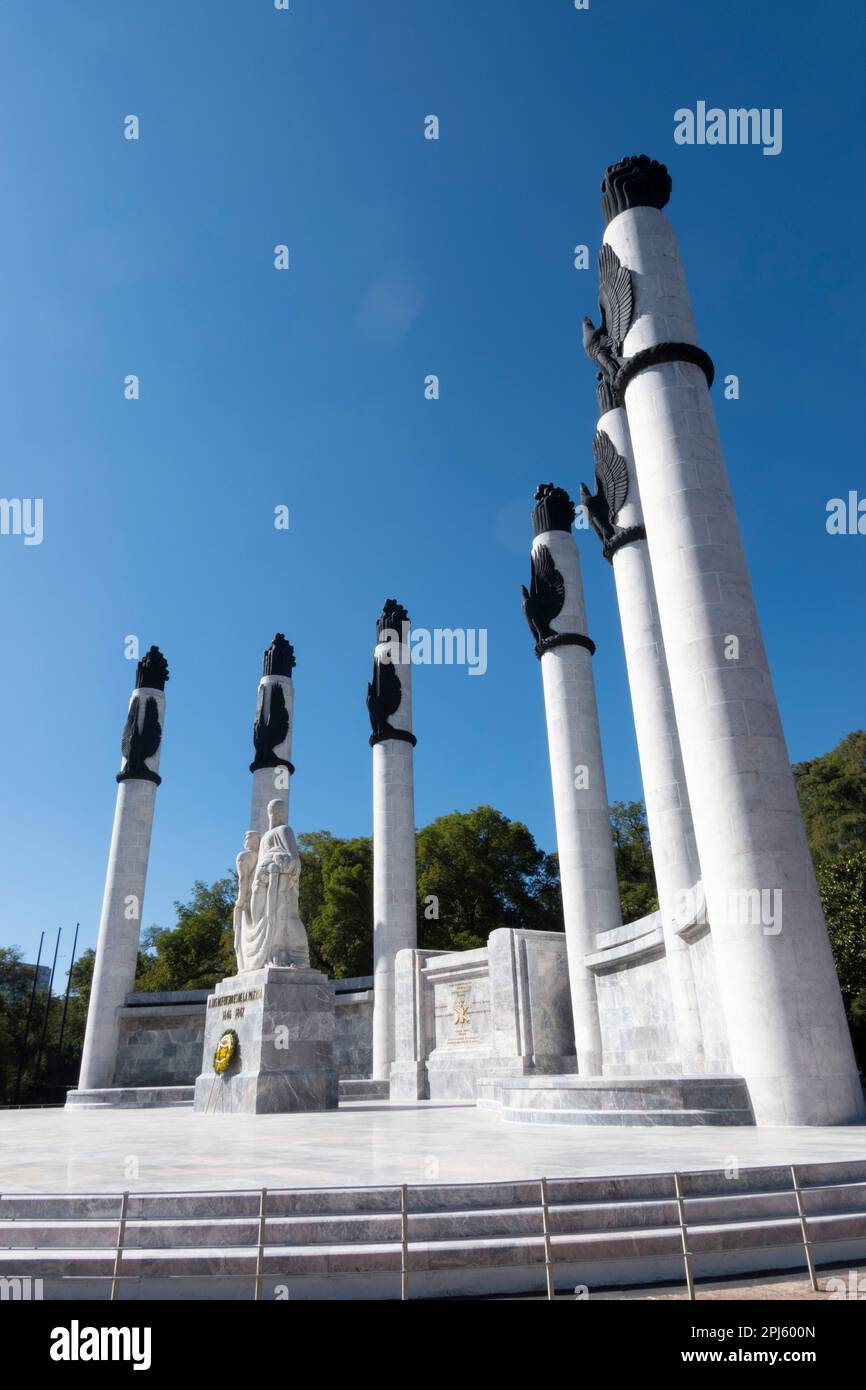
[195,966,338,1115]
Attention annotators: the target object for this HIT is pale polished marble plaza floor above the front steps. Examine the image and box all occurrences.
[0,1101,866,1193]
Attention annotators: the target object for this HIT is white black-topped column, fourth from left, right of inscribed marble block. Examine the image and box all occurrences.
[523,484,623,1076]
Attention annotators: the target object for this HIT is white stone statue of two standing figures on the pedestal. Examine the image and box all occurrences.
[234,801,310,974]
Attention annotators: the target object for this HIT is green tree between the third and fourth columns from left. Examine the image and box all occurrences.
[417,806,563,951]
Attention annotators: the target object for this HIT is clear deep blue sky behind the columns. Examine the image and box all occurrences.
[0,0,866,966]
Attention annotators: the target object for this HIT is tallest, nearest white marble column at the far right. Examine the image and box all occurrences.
[595,156,866,1125]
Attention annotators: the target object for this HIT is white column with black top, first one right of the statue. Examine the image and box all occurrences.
[367,599,417,1080]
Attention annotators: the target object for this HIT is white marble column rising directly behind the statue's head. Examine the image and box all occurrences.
[250,632,296,834]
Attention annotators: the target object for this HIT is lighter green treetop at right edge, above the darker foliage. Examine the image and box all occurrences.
[794,728,866,863]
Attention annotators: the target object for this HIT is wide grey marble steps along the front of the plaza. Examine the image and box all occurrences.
[0,1161,866,1301]
